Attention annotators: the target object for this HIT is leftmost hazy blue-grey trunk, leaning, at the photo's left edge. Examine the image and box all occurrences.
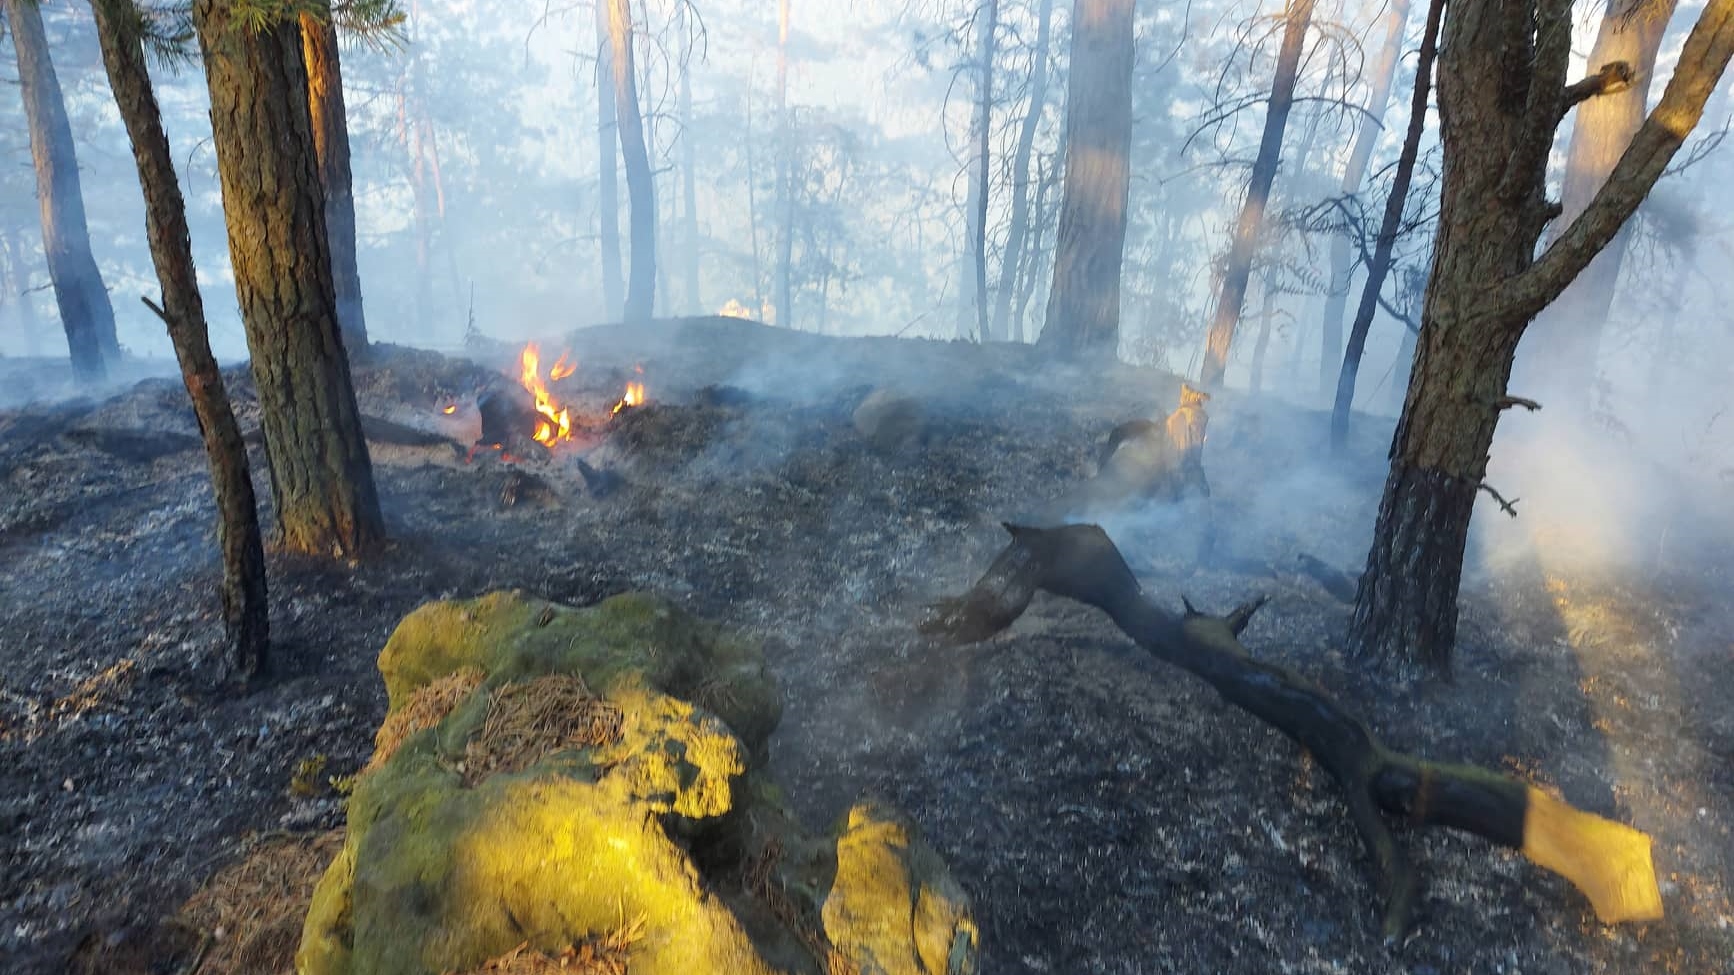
[5,0,120,382]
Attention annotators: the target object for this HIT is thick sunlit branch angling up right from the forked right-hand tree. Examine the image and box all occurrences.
[1493,0,1734,323]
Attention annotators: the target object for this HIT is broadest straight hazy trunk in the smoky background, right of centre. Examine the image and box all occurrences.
[1037,0,1132,357]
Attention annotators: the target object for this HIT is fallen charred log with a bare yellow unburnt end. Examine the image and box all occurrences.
[921,524,1661,940]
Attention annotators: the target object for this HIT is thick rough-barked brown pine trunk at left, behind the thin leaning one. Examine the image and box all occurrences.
[192,0,385,557]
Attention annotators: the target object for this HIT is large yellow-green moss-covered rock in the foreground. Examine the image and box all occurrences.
[297,593,975,975]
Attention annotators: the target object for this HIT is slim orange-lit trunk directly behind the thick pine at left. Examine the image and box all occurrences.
[302,10,368,356]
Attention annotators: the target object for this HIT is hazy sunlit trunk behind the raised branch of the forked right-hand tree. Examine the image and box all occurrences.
[1517,0,1675,405]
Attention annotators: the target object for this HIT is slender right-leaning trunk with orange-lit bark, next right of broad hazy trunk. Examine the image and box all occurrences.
[1200,0,1313,387]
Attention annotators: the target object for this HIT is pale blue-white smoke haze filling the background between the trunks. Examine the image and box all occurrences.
[0,0,1734,560]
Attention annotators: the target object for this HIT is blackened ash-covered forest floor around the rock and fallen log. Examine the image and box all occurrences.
[0,319,1734,975]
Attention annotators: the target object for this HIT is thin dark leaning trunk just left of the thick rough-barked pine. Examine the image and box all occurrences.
[90,0,269,675]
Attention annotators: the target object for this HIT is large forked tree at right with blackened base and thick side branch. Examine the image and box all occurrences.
[1349,0,1734,670]
